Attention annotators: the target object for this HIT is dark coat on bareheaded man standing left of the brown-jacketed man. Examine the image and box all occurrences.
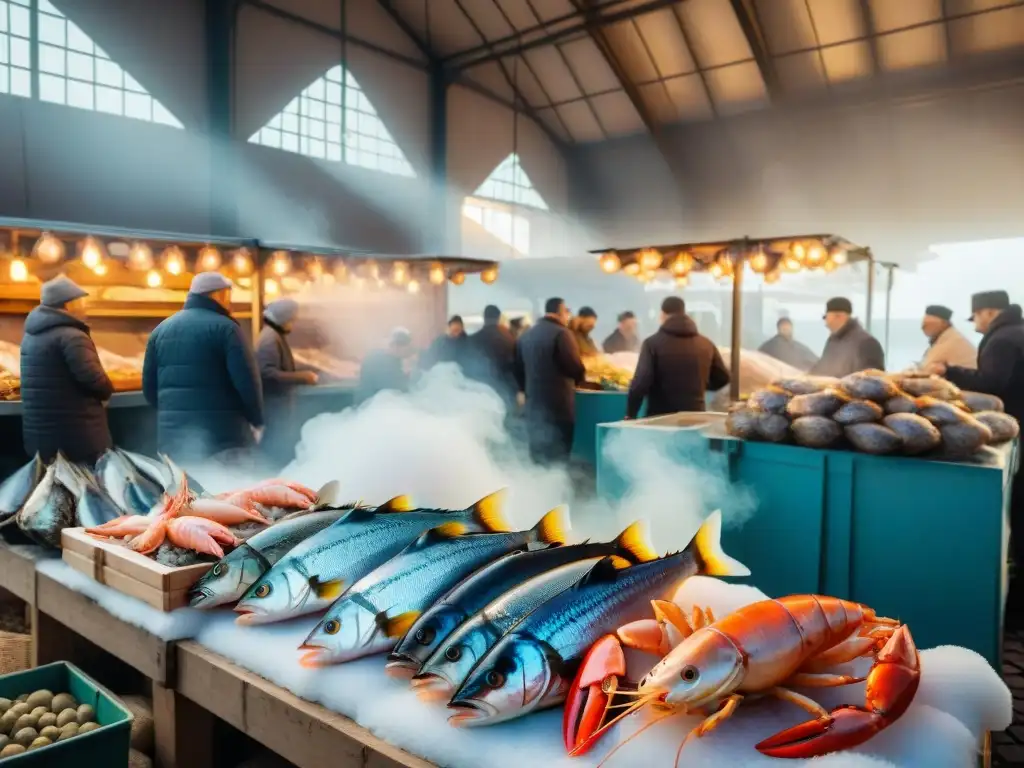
[514,317,587,424]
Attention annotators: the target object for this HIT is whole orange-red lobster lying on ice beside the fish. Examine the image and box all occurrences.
[562,595,921,760]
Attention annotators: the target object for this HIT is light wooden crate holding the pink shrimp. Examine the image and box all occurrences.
[60,528,210,610]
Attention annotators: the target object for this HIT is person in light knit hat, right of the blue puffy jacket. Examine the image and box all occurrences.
[256,299,317,464]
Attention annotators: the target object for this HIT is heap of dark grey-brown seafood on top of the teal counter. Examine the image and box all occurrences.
[726,371,1020,459]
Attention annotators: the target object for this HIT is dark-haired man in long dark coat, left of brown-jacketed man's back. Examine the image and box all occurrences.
[514,298,587,463]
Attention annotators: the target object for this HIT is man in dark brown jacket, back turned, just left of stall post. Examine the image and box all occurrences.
[626,296,729,419]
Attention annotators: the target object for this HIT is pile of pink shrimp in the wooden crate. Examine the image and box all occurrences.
[85,476,316,558]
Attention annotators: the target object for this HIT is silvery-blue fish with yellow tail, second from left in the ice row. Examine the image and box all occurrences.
[234,492,508,624]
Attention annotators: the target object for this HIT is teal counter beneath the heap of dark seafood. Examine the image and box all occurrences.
[597,414,1019,669]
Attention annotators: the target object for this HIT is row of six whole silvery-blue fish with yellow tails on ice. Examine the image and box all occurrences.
[191,492,749,725]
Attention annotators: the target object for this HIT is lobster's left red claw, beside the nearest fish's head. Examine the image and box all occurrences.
[562,635,626,757]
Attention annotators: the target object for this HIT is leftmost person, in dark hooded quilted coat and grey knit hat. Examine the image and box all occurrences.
[22,274,114,464]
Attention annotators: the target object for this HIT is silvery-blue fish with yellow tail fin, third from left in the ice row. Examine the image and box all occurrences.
[300,507,567,666]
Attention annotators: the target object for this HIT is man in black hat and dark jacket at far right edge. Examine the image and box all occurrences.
[928,291,1024,627]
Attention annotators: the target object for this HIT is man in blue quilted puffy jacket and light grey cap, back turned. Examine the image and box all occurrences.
[142,272,263,462]
